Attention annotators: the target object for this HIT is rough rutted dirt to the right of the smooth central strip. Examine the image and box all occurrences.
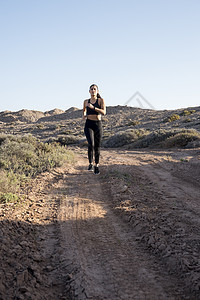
[101,149,200,299]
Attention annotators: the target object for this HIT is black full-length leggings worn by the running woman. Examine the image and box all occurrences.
[84,119,102,164]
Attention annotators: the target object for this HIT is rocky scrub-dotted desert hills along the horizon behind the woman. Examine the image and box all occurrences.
[0,105,200,148]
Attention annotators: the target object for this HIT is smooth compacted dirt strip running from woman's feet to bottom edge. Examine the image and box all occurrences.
[53,154,184,300]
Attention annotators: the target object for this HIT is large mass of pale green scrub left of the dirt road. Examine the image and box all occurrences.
[0,134,73,202]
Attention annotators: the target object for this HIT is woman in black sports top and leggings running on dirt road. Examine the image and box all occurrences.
[83,84,106,175]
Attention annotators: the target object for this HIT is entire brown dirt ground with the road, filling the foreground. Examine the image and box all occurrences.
[0,148,200,300]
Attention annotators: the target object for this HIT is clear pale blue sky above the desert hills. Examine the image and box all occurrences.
[0,0,200,111]
